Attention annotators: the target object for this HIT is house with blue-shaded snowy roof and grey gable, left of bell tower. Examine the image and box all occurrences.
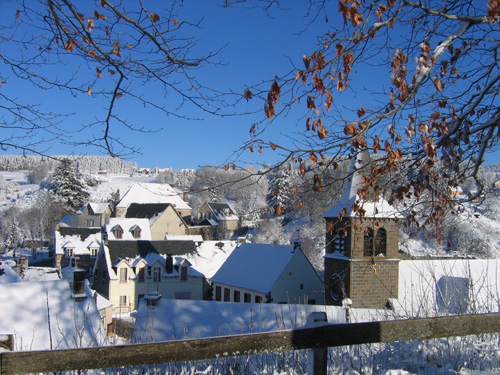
[210,243,323,304]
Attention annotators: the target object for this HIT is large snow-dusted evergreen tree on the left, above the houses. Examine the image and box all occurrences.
[49,159,90,212]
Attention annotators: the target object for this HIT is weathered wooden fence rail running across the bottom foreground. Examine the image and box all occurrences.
[0,313,500,375]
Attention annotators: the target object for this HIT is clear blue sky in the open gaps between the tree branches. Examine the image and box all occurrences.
[0,0,500,169]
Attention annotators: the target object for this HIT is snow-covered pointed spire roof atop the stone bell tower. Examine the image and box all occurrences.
[323,152,403,219]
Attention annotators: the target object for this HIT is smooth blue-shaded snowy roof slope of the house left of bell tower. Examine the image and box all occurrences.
[211,243,299,293]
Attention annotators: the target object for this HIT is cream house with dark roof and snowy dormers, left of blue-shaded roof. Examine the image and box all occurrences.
[93,240,210,313]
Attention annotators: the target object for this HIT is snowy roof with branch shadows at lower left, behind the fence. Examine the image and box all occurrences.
[0,280,108,350]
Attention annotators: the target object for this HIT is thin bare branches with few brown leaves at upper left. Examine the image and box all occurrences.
[0,0,227,156]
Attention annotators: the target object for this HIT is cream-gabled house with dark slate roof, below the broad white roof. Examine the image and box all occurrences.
[123,203,188,241]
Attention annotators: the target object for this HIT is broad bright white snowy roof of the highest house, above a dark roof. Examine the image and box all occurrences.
[117,183,191,210]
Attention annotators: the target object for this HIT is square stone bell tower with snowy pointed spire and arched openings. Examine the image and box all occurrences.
[323,152,402,308]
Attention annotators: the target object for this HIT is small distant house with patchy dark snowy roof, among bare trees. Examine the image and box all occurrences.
[192,202,239,240]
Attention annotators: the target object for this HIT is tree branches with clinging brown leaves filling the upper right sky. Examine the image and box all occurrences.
[236,0,500,231]
